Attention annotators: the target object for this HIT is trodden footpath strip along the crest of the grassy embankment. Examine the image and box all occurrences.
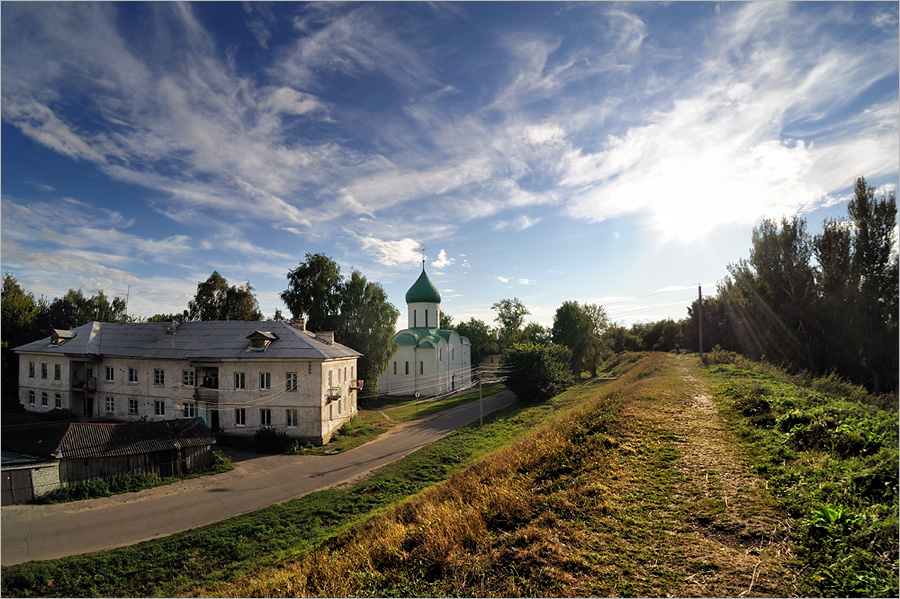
[596,356,794,597]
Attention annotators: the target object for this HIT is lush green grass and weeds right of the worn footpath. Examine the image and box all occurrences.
[708,356,900,597]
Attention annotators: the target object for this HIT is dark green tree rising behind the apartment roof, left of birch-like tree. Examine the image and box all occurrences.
[279,254,342,331]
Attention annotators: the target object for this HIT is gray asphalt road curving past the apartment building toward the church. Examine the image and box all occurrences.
[0,391,515,566]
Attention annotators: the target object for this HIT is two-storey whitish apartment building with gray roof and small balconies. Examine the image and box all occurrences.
[16,321,361,445]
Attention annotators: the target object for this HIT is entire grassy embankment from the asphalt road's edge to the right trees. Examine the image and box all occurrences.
[2,354,898,597]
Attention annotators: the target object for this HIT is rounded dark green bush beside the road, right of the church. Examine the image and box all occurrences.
[504,343,574,401]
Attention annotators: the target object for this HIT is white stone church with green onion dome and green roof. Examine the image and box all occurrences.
[378,261,472,397]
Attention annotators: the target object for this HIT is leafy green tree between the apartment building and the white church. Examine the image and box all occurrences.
[331,269,400,390]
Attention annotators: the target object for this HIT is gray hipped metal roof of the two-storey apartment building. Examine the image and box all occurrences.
[15,320,362,360]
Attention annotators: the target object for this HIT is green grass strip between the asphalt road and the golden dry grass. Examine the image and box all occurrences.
[0,386,579,597]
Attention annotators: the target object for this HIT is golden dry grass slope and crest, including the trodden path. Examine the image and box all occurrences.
[197,355,794,597]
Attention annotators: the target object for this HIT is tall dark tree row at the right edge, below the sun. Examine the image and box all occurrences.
[683,177,900,393]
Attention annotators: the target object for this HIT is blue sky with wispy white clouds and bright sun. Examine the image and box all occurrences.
[0,1,900,329]
